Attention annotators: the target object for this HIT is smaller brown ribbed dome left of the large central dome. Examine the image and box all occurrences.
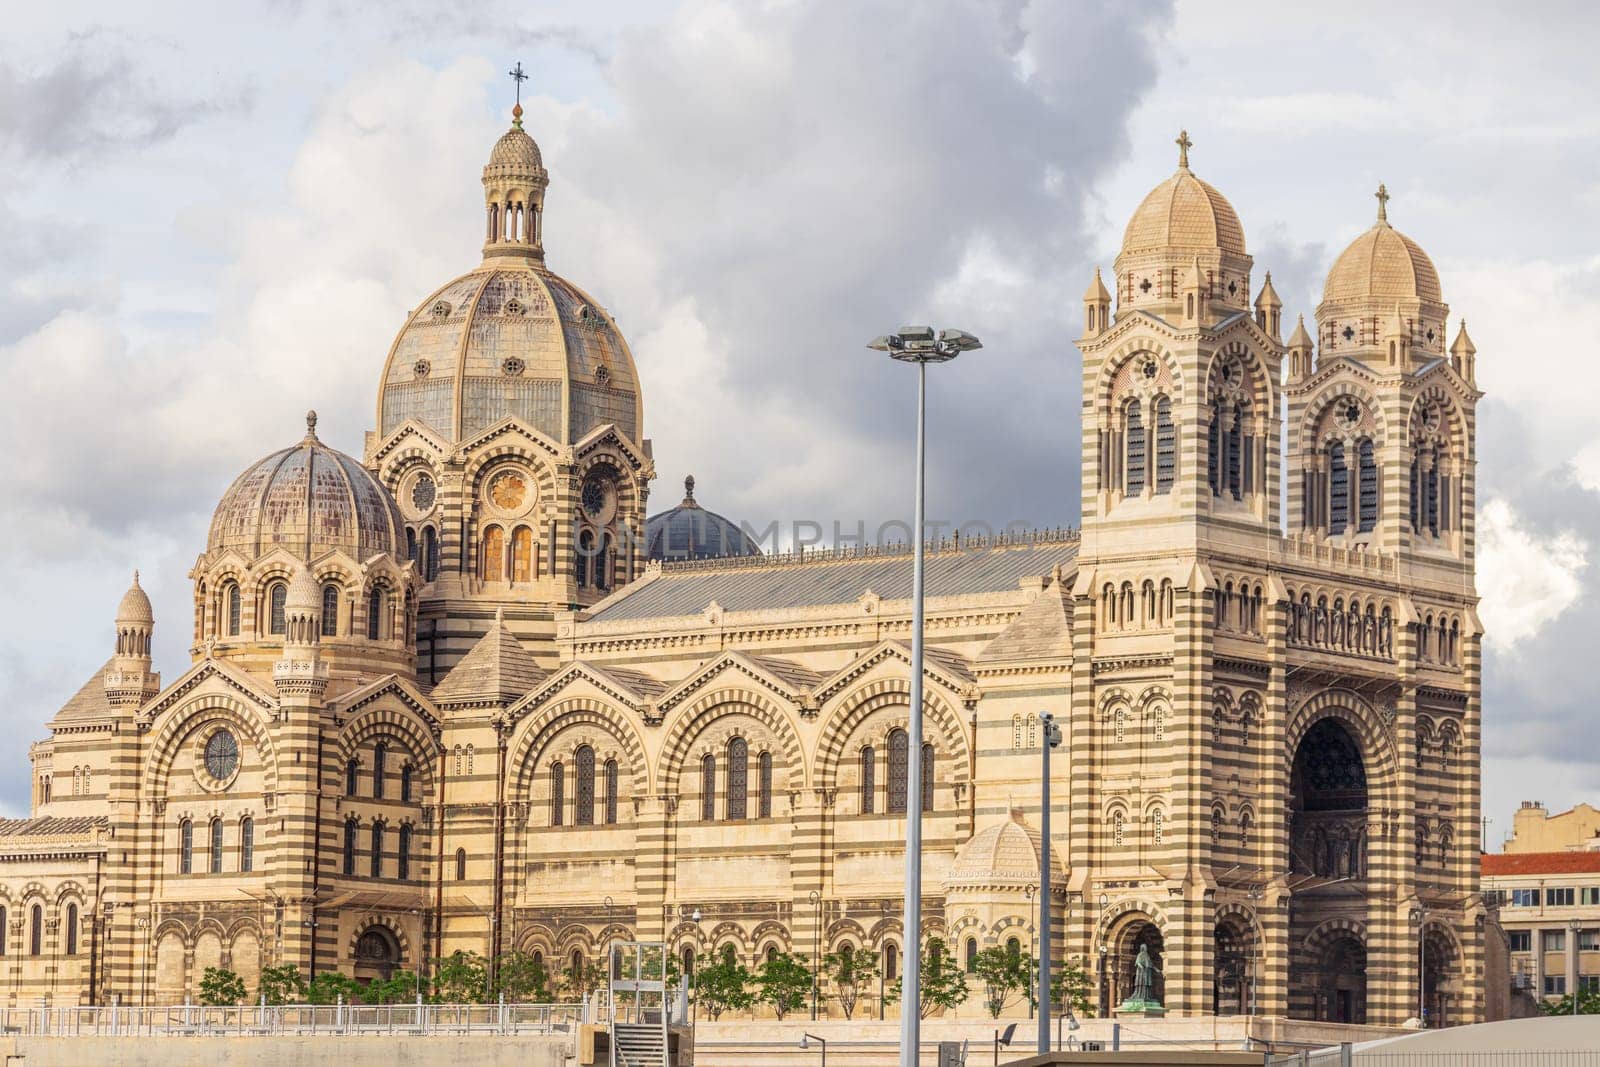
[206,413,405,561]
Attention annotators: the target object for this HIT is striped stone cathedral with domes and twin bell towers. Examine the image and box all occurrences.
[0,107,1486,1025]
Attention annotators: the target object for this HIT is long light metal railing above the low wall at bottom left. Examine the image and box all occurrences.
[0,1003,589,1037]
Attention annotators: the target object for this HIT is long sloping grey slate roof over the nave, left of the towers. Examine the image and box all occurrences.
[590,539,1078,622]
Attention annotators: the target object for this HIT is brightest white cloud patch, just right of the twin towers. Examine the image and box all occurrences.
[1478,499,1589,651]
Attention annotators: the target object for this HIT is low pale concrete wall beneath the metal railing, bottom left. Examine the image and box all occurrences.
[0,1035,573,1067]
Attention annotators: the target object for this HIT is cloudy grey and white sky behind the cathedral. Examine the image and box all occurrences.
[0,0,1600,841]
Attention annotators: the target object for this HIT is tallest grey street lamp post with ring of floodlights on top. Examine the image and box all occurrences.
[867,326,982,1067]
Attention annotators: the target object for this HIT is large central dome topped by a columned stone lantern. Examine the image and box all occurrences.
[378,107,643,445]
